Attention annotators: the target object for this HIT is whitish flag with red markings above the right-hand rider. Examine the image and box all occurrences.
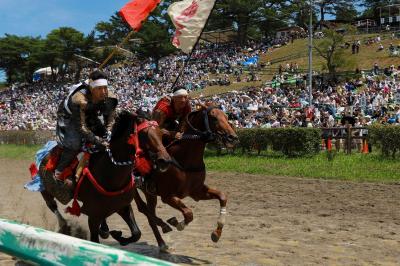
[168,0,215,53]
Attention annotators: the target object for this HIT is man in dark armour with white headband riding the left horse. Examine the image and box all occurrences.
[54,70,118,184]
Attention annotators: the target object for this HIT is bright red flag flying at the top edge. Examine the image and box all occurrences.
[119,0,161,31]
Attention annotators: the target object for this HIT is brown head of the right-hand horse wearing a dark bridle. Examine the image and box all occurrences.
[186,104,239,148]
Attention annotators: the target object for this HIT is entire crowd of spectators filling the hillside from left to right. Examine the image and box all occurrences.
[0,39,400,130]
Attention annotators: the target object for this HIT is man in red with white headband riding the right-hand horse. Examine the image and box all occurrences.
[152,87,192,142]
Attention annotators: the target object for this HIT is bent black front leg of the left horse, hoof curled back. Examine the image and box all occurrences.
[110,205,142,246]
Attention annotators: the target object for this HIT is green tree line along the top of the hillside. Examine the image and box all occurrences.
[0,0,382,83]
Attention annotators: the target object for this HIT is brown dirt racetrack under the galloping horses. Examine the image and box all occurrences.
[0,159,400,266]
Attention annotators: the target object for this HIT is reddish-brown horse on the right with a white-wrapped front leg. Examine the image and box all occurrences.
[141,106,238,250]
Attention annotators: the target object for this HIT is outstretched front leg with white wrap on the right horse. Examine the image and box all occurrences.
[192,185,227,242]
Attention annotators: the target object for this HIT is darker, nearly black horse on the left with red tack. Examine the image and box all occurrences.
[39,112,171,245]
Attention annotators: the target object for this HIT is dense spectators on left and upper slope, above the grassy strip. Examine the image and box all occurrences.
[0,43,266,130]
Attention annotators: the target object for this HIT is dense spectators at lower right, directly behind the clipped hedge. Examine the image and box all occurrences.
[211,67,400,128]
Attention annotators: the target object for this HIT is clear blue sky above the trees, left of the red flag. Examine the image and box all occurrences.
[0,0,129,37]
